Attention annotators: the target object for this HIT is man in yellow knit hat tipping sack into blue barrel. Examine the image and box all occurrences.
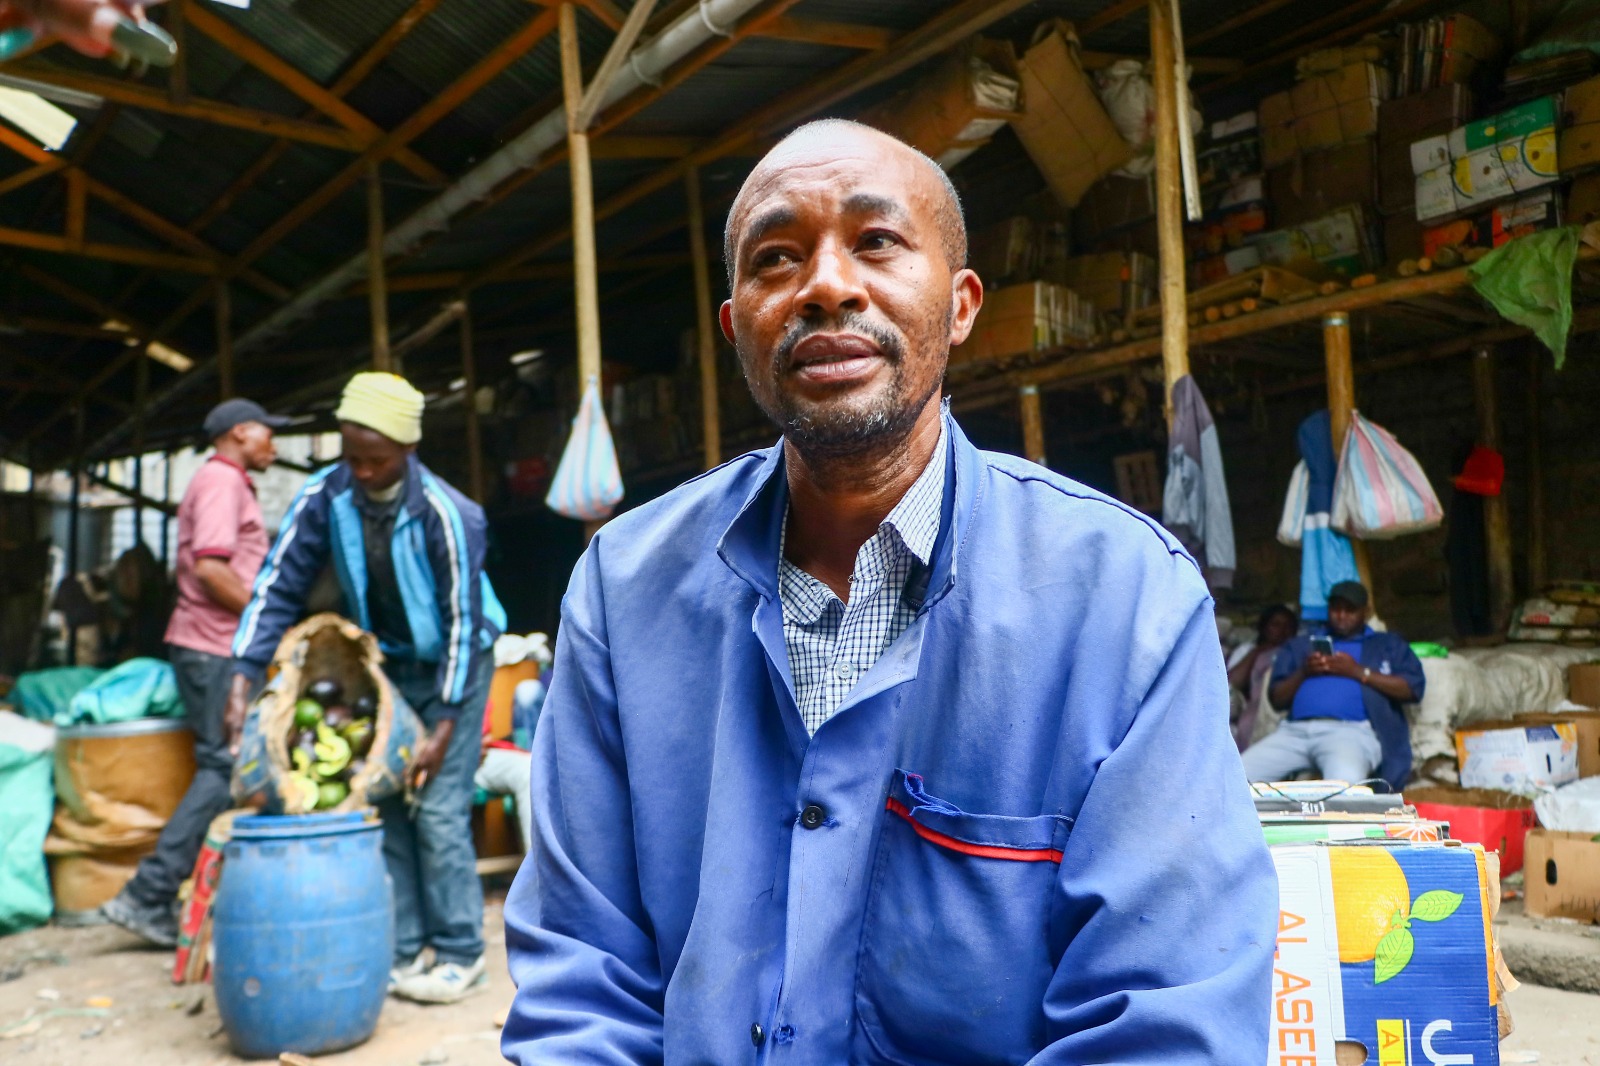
[227,373,506,1002]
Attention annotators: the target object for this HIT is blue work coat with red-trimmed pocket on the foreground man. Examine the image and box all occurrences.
[502,421,1277,1066]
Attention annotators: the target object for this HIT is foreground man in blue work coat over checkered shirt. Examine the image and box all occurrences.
[502,122,1277,1066]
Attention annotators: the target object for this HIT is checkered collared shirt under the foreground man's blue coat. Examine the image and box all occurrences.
[778,423,949,735]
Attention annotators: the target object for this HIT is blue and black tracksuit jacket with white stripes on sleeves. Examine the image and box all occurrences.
[234,455,506,714]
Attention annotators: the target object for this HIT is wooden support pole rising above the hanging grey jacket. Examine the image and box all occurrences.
[1150,0,1189,424]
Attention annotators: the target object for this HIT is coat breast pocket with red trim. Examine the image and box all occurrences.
[856,770,1072,1064]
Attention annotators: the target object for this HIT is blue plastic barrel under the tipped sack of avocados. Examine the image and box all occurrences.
[211,812,394,1058]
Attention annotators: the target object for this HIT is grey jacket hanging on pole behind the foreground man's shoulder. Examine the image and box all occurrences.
[1162,375,1235,591]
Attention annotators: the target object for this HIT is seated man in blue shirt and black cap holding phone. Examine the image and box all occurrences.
[1245,581,1427,789]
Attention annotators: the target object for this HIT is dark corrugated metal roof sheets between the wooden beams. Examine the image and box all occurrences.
[0,0,1427,455]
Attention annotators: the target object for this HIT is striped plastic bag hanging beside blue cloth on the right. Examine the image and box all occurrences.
[1333,411,1445,541]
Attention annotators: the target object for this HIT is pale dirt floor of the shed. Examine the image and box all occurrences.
[0,901,1600,1066]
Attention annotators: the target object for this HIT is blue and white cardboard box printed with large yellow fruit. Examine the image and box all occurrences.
[1267,840,1499,1066]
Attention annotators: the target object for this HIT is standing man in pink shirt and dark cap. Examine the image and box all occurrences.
[101,393,288,948]
